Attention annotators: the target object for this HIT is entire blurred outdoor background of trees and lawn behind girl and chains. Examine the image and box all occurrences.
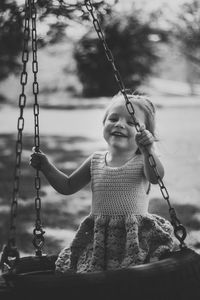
[0,0,200,255]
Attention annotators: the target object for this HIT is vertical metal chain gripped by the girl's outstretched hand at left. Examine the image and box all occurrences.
[29,0,45,256]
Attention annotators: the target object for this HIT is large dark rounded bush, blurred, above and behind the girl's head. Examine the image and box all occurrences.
[74,11,163,96]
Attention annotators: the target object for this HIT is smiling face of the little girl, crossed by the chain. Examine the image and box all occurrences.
[103,99,145,152]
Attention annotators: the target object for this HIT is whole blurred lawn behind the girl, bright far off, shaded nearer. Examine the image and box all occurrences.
[0,97,200,255]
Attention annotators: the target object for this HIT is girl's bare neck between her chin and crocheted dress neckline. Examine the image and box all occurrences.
[106,148,136,167]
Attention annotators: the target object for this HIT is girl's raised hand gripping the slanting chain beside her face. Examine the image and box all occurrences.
[135,125,154,153]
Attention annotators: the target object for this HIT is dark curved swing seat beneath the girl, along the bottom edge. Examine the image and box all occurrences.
[0,248,200,300]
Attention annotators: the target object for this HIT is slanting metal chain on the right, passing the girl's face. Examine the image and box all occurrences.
[85,0,187,248]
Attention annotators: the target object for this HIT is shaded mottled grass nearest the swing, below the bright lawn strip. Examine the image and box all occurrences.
[0,130,200,254]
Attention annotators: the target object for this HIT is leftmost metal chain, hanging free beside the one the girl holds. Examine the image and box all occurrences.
[1,1,30,268]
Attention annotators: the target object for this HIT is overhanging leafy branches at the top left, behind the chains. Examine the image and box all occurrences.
[0,0,110,80]
